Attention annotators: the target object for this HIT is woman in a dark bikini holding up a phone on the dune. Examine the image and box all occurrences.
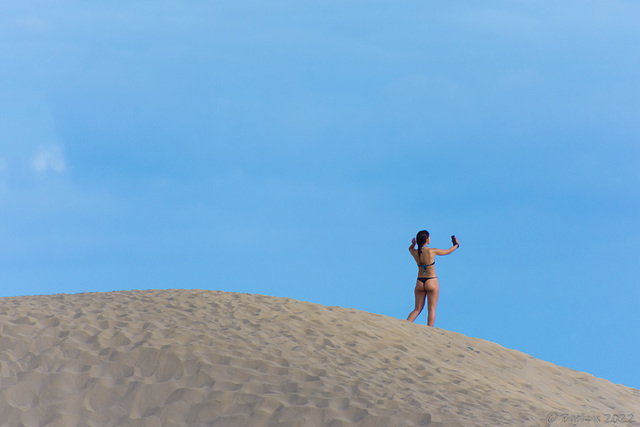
[407,230,460,326]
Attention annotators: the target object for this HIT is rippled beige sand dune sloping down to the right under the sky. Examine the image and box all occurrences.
[0,290,640,427]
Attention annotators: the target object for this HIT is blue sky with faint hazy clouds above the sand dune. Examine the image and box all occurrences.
[0,0,640,392]
